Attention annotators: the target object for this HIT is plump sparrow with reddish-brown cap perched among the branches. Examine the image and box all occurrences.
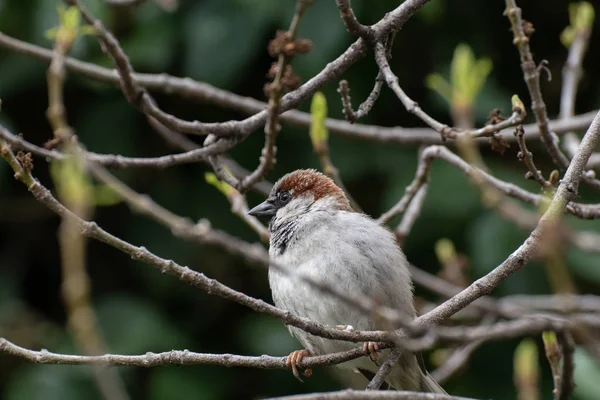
[248,169,446,393]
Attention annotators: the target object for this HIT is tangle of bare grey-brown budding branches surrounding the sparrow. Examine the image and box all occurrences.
[0,0,600,399]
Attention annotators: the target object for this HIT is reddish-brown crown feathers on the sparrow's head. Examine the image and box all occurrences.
[275,169,352,211]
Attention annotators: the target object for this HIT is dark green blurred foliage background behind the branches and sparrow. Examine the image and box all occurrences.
[0,0,600,400]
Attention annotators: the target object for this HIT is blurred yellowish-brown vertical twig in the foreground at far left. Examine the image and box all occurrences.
[44,13,129,400]
